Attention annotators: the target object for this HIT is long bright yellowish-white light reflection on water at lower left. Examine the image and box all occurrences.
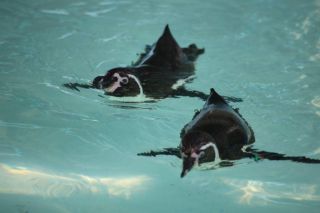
[0,163,151,199]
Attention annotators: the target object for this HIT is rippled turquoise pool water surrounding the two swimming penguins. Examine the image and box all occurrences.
[0,0,320,213]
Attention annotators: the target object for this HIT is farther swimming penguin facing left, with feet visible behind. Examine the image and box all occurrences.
[64,25,241,102]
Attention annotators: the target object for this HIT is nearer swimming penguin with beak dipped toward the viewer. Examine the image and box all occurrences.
[138,89,320,177]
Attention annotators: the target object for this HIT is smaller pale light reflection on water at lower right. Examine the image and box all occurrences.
[223,179,320,204]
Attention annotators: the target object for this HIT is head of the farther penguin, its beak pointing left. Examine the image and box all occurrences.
[92,68,142,97]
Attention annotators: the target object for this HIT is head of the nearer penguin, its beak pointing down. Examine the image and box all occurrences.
[180,131,219,178]
